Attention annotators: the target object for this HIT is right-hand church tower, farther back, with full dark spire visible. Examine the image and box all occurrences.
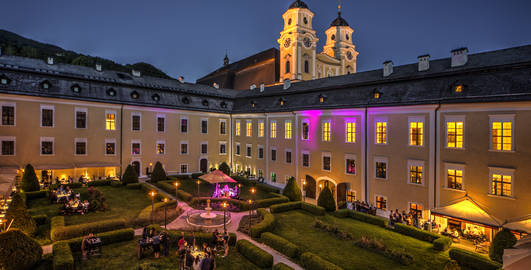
[323,4,359,74]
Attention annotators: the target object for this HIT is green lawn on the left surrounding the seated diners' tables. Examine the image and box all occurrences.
[28,186,151,225]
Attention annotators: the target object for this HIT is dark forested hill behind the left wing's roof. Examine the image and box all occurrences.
[0,29,171,79]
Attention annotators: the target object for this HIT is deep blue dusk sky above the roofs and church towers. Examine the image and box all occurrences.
[0,0,531,82]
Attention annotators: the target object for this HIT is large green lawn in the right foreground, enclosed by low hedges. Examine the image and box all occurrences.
[273,210,454,269]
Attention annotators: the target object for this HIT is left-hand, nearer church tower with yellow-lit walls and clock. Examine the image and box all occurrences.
[277,0,319,81]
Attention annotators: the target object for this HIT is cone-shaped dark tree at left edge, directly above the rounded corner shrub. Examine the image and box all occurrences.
[6,192,37,235]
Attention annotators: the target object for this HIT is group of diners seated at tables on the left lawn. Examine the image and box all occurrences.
[49,185,90,215]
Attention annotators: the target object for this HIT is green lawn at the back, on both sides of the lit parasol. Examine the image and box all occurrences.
[165,177,272,200]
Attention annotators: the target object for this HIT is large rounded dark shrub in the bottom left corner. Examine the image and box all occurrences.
[0,229,42,270]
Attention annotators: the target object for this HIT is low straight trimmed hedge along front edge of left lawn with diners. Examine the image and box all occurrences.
[50,218,125,241]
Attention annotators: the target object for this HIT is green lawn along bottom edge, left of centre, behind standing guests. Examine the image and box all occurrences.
[74,239,259,270]
